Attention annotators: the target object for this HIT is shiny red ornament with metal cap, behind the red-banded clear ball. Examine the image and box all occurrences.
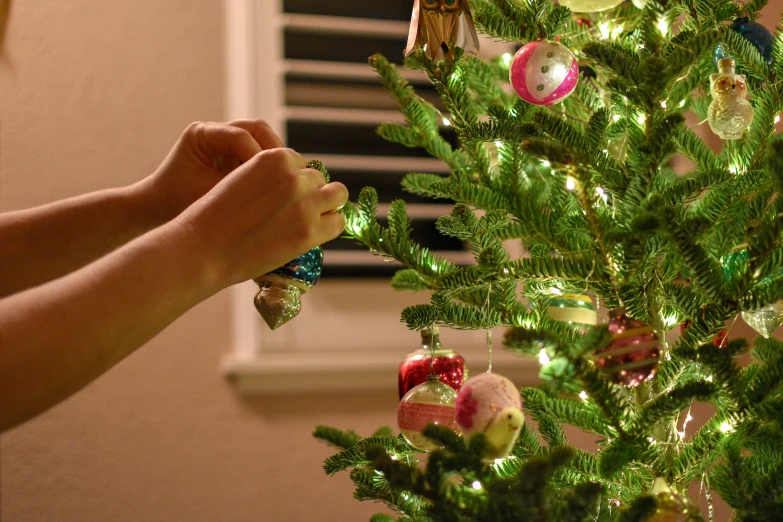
[397,327,468,399]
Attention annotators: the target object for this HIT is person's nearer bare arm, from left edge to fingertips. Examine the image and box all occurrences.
[0,149,347,431]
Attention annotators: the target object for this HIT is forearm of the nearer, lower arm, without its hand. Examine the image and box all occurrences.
[0,223,221,431]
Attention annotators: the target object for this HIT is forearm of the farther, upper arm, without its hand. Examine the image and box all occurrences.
[0,182,160,297]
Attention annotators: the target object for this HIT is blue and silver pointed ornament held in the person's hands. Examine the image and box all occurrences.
[253,247,324,330]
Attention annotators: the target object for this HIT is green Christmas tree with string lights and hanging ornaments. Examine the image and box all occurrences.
[315,0,783,522]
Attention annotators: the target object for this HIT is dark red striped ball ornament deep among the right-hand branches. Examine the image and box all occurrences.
[594,308,661,387]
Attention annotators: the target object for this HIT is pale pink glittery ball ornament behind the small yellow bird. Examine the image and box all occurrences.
[454,372,522,437]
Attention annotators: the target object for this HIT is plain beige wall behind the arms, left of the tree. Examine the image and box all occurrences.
[0,0,779,522]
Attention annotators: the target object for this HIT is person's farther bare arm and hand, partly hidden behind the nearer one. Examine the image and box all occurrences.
[0,120,282,297]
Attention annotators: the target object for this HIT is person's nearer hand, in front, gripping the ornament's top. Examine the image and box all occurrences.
[174,148,348,287]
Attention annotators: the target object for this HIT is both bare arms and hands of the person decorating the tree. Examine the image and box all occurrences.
[0,120,348,431]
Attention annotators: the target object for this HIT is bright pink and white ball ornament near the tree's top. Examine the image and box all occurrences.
[509,40,579,106]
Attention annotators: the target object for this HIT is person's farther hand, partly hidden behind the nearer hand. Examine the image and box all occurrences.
[133,120,283,223]
